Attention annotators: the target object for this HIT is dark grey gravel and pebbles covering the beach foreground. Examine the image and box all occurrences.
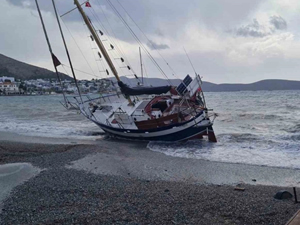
[0,142,299,224]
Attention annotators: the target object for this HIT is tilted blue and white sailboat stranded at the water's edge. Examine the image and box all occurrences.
[37,0,217,142]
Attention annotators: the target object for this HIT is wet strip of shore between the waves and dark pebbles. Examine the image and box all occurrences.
[0,132,300,187]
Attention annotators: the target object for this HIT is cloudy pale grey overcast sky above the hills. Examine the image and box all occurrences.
[0,0,300,83]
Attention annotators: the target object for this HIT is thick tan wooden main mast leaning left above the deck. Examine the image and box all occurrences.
[74,0,134,105]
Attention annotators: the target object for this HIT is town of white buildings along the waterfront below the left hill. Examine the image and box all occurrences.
[0,76,115,96]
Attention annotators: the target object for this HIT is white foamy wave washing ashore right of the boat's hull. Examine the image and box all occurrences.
[147,135,300,169]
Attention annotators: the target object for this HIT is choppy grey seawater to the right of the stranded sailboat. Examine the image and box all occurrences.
[148,91,300,168]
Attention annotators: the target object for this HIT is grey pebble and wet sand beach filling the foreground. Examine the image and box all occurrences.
[0,135,300,224]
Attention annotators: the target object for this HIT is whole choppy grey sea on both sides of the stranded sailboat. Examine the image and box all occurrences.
[0,91,300,169]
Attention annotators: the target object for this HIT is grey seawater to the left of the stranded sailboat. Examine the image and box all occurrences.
[0,95,101,139]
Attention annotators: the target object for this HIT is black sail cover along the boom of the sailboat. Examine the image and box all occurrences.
[118,81,171,95]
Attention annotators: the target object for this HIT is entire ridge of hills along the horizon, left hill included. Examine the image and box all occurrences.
[0,54,300,92]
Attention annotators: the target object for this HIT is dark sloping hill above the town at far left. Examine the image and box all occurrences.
[0,54,72,80]
